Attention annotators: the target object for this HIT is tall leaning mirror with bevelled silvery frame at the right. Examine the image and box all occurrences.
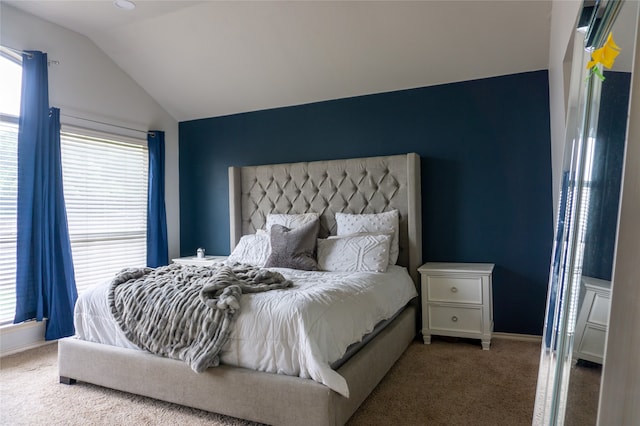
[533,0,639,425]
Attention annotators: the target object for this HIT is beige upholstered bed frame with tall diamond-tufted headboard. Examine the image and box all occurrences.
[58,154,422,425]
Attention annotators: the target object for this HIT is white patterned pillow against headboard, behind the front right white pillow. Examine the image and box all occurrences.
[336,210,400,265]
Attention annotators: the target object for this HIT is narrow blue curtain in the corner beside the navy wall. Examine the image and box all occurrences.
[147,130,169,268]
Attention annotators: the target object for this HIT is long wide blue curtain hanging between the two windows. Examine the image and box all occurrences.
[14,51,77,340]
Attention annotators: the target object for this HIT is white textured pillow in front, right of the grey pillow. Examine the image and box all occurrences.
[318,234,392,272]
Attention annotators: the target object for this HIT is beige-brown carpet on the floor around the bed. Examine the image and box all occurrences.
[0,338,596,426]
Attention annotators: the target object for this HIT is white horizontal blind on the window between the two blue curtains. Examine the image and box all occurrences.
[61,127,148,293]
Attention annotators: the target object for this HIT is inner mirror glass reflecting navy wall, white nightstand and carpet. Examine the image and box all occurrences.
[564,1,638,426]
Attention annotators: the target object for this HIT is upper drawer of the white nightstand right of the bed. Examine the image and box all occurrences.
[426,276,482,304]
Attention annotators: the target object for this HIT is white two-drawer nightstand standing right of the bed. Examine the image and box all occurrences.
[418,263,494,350]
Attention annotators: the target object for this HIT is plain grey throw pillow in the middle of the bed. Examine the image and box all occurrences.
[265,219,320,271]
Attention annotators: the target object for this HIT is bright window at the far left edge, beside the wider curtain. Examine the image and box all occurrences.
[0,49,22,324]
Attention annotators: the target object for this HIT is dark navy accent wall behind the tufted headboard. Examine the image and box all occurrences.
[179,71,553,335]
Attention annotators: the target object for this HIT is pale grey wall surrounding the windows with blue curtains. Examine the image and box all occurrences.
[0,2,180,355]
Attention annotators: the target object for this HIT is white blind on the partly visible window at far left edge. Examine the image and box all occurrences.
[0,120,18,324]
